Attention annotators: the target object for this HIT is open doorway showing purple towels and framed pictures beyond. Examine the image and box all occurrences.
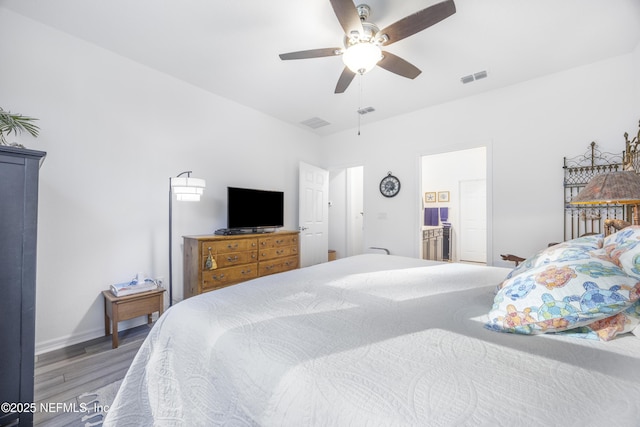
[419,147,487,263]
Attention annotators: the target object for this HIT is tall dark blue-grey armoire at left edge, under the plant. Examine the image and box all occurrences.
[0,146,46,426]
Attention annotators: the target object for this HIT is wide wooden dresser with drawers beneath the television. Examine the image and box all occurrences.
[183,231,300,299]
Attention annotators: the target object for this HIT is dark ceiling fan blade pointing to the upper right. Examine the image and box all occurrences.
[378,0,456,46]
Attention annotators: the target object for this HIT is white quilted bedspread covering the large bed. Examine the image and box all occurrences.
[104,255,640,427]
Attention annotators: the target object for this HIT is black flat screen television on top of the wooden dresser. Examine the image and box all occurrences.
[227,187,284,232]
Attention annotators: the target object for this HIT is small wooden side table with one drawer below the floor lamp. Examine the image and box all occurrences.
[102,288,165,348]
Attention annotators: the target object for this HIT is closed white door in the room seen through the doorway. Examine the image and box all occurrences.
[459,179,487,263]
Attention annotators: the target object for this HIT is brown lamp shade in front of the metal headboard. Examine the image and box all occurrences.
[571,171,640,205]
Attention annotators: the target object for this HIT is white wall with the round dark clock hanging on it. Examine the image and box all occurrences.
[323,49,640,266]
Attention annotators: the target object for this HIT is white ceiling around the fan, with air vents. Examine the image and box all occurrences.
[0,0,640,135]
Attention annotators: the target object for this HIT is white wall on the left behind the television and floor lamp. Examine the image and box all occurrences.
[0,8,319,352]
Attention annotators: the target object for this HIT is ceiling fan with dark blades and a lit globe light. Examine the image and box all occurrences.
[280,0,456,93]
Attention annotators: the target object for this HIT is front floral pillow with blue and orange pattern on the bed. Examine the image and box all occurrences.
[487,254,640,339]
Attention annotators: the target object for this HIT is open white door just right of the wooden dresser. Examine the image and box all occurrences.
[299,162,329,267]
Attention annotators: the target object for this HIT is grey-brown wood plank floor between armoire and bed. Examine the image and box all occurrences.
[34,325,151,427]
